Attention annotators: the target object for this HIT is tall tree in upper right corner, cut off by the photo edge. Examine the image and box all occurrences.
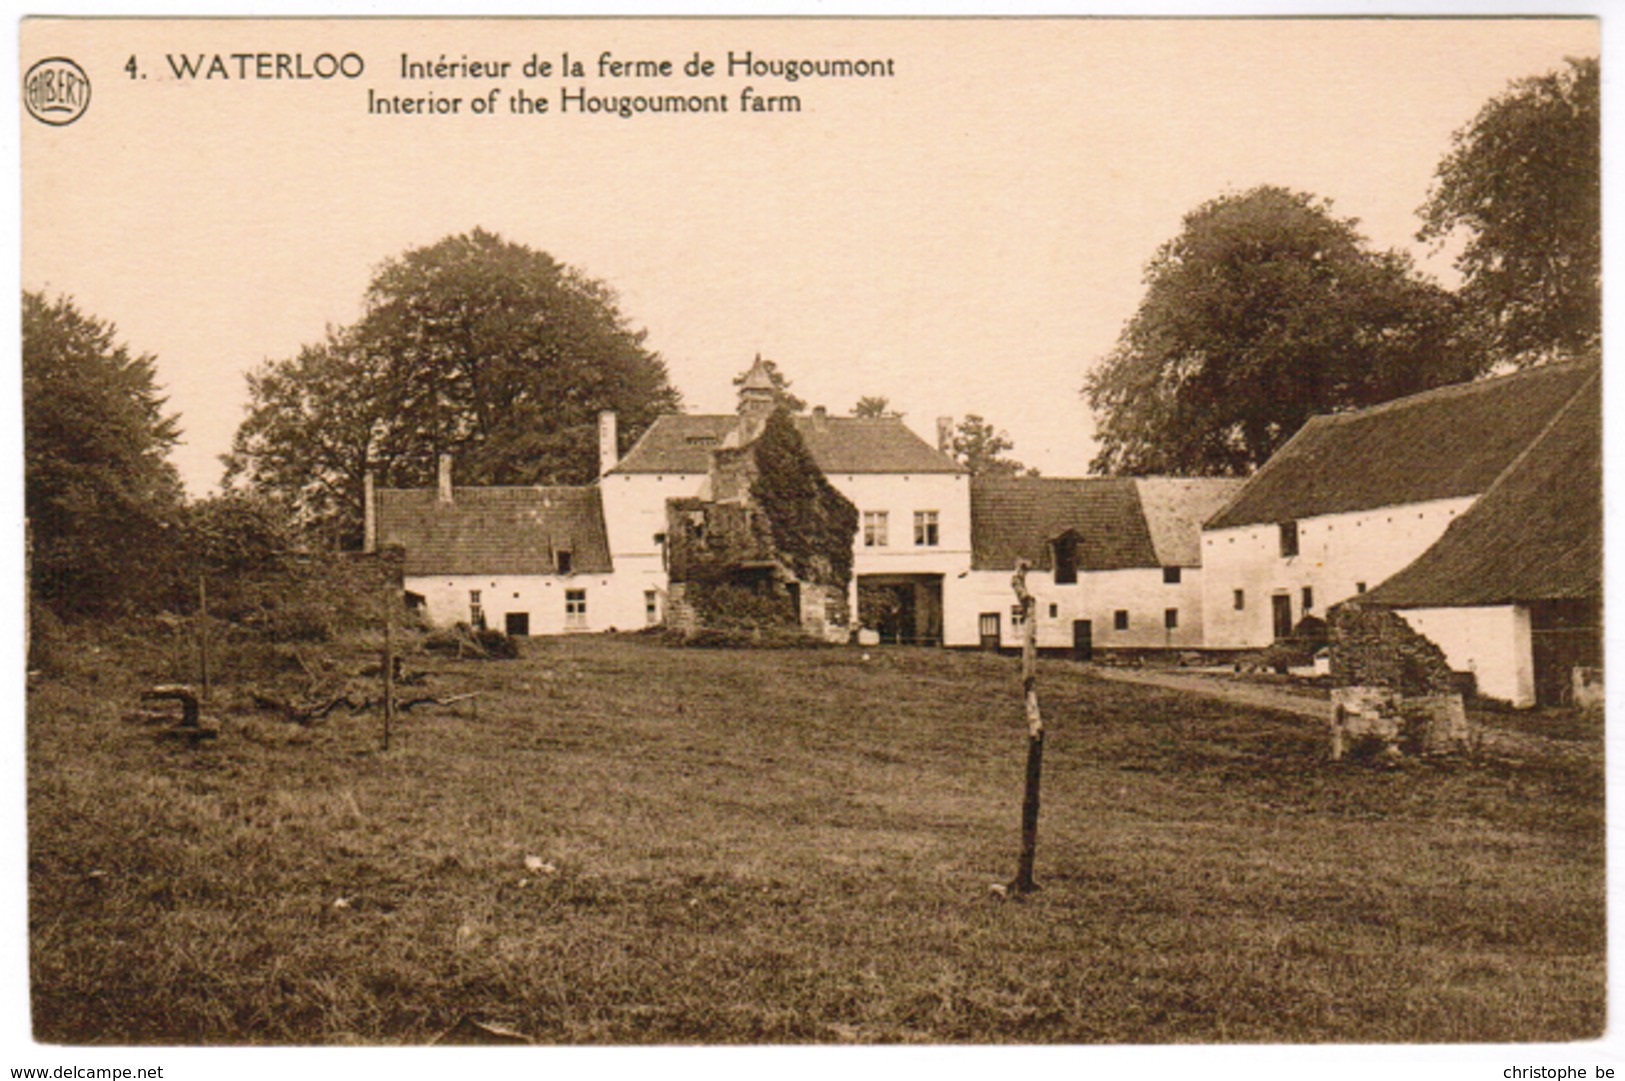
[1417,59,1602,364]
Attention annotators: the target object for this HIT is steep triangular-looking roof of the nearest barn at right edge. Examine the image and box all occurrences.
[1362,371,1602,608]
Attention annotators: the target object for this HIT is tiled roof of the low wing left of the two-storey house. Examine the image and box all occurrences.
[377,488,614,575]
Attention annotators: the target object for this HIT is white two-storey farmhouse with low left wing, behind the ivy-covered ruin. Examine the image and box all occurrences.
[367,358,970,644]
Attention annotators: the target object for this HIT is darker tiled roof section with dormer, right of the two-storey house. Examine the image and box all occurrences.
[970,476,1162,571]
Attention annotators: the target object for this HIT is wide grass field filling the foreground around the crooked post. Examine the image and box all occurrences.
[28,637,1606,1044]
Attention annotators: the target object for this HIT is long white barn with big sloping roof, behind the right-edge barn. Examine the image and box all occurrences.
[1201,361,1599,652]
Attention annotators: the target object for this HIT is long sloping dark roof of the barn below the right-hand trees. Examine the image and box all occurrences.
[1207,361,1597,530]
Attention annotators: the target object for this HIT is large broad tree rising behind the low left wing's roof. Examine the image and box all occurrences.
[228,229,679,545]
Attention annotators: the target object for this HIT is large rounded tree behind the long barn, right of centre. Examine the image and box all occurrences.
[1084,187,1482,475]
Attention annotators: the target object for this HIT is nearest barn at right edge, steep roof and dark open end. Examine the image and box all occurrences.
[1365,366,1602,707]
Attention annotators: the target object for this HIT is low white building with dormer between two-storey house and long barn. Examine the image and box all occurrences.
[947,476,1242,658]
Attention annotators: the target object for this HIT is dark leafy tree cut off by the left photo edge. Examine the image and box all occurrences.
[23,291,180,613]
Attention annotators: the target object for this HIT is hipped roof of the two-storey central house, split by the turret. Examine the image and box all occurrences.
[609,413,965,475]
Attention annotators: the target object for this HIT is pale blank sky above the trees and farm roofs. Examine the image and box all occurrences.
[21,18,1599,494]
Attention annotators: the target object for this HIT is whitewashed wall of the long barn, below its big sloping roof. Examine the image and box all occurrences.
[1203,496,1476,649]
